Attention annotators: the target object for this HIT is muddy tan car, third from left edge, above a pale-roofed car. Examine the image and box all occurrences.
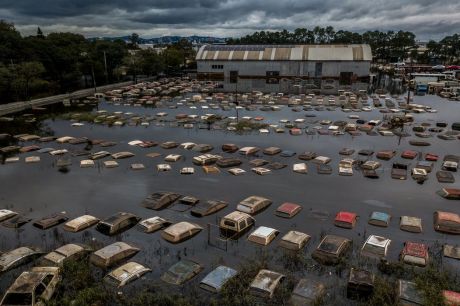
[89,241,140,268]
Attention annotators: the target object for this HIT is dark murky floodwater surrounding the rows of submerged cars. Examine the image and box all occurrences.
[0,96,460,303]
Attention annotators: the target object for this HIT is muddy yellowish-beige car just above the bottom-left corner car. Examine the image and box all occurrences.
[40,243,92,267]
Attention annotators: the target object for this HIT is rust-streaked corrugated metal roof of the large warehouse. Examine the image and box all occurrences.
[196,44,372,61]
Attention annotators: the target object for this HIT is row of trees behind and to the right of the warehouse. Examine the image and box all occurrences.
[227,26,460,64]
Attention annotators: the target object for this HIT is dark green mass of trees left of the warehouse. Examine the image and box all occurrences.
[0,20,194,104]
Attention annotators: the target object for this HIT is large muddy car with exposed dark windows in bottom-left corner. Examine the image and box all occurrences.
[0,267,61,306]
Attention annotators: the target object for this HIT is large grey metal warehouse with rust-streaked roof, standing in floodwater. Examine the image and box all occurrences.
[196,45,372,94]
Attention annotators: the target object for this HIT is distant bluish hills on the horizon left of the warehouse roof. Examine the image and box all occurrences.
[88,35,227,45]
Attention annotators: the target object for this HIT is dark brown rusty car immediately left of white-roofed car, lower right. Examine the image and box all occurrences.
[311,235,351,265]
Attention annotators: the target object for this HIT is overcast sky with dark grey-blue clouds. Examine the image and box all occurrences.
[0,0,460,40]
